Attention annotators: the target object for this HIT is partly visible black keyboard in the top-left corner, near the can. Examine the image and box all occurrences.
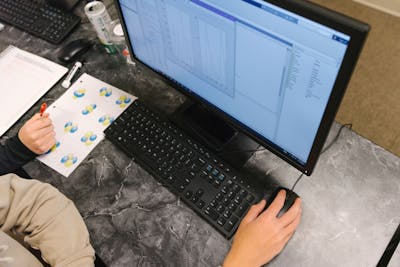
[0,0,80,44]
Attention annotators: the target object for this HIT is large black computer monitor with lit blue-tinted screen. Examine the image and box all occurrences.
[115,0,369,175]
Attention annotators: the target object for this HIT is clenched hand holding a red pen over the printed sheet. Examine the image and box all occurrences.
[18,113,56,155]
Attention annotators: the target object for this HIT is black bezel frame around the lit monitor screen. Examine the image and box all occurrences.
[114,0,370,175]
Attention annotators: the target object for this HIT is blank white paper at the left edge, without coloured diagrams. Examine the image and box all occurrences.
[0,46,68,135]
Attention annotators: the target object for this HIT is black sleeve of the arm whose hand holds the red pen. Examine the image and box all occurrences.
[0,135,37,175]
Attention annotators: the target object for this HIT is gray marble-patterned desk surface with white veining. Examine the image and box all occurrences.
[0,1,400,267]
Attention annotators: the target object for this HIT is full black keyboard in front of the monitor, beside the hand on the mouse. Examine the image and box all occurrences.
[104,100,263,238]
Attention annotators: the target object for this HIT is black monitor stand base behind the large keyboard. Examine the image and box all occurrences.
[170,100,260,168]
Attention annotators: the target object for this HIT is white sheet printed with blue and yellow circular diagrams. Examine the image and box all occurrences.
[38,73,136,177]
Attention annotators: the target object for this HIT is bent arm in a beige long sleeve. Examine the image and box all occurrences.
[0,174,94,267]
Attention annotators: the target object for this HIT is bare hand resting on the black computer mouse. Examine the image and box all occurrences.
[223,190,301,267]
